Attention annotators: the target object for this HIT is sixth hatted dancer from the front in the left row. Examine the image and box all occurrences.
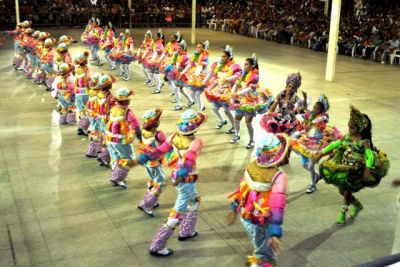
[74,51,90,136]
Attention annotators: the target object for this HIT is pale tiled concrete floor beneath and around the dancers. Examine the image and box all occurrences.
[0,29,400,266]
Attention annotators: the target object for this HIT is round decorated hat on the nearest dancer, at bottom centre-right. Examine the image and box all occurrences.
[253,133,289,168]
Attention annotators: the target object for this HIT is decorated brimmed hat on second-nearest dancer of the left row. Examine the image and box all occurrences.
[176,109,206,135]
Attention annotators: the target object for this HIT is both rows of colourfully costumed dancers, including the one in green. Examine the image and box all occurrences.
[3,19,389,266]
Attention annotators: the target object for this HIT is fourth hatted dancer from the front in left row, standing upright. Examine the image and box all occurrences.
[106,88,142,189]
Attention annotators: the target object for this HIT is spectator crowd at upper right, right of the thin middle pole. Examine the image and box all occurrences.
[206,0,400,63]
